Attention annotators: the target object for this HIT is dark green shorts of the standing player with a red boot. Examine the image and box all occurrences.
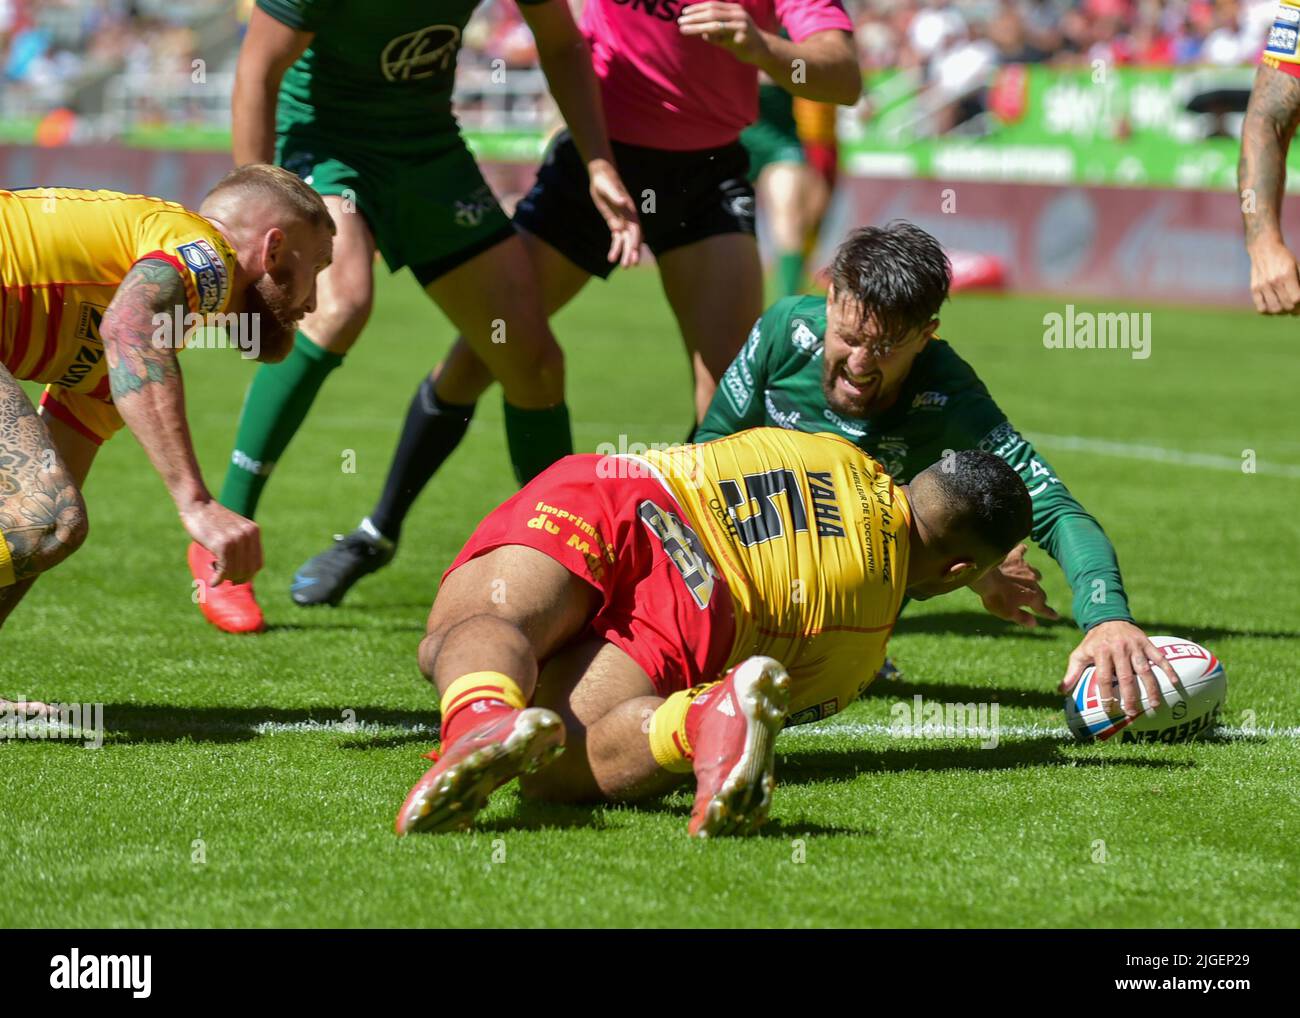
[276,131,515,286]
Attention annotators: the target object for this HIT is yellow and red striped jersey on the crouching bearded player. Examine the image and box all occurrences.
[0,187,235,400]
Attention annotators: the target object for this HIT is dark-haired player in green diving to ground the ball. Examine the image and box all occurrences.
[697,222,1175,716]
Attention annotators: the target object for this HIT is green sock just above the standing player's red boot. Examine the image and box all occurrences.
[221,333,343,519]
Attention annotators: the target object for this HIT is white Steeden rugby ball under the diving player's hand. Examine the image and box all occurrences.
[1065,636,1227,742]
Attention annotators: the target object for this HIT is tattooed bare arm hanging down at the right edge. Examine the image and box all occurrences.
[1236,64,1300,315]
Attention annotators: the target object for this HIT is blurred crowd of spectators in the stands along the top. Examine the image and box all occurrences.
[0,0,1277,123]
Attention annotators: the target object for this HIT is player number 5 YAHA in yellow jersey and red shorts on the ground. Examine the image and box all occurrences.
[397,428,1032,836]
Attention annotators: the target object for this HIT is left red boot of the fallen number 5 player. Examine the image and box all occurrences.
[394,707,564,836]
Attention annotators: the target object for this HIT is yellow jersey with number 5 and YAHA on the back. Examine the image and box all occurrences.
[644,428,911,724]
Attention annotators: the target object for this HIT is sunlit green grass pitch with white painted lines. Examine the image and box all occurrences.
[0,269,1300,927]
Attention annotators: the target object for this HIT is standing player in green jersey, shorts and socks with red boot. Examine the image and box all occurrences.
[189,0,641,632]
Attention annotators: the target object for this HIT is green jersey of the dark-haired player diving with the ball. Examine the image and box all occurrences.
[696,296,1132,629]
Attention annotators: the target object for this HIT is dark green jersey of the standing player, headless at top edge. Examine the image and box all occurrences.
[257,0,546,153]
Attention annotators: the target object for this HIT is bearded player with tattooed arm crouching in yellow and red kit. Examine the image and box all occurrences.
[0,165,334,652]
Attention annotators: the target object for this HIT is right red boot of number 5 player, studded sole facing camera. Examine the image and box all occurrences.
[686,657,790,837]
